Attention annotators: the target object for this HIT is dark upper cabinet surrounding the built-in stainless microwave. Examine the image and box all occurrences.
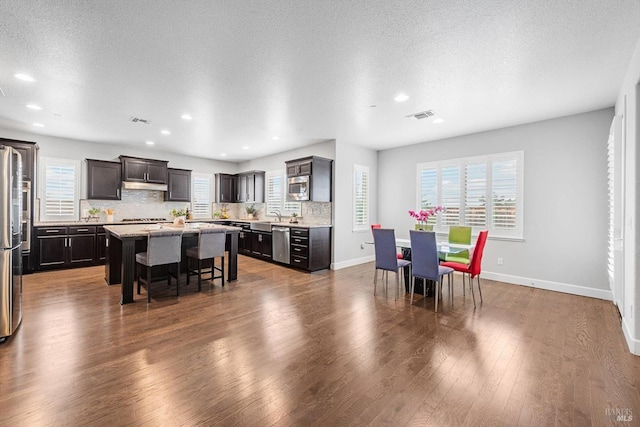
[285,156,333,202]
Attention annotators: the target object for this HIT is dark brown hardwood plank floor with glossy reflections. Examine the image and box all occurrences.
[0,256,640,426]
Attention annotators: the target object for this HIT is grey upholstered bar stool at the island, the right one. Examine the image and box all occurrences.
[187,227,226,291]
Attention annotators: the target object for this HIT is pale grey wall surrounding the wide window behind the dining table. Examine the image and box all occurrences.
[378,108,613,299]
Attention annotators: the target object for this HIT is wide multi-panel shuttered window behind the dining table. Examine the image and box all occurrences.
[417,151,524,238]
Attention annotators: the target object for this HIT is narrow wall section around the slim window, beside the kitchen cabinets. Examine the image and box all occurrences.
[332,141,378,269]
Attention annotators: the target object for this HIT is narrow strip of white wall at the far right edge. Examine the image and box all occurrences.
[615,35,640,355]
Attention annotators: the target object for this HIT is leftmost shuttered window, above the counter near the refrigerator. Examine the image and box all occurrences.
[40,157,80,221]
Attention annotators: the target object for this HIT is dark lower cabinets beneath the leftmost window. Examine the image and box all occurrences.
[35,225,106,270]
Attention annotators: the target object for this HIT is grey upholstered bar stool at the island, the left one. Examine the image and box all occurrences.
[136,230,182,303]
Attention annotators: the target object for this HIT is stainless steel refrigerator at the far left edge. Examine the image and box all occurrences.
[0,146,22,342]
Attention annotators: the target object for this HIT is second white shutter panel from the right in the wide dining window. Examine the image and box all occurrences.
[464,163,487,227]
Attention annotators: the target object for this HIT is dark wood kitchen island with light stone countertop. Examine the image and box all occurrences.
[104,223,240,304]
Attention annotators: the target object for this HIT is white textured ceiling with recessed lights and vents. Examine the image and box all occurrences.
[0,0,640,161]
